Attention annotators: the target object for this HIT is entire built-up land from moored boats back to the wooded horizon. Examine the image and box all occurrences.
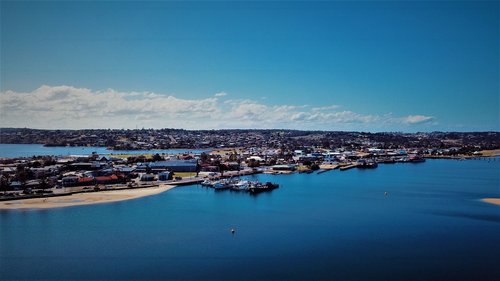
[0,129,500,206]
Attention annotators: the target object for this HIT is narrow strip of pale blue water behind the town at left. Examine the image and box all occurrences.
[0,144,207,157]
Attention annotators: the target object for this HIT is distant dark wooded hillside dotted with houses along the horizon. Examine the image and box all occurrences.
[0,128,500,154]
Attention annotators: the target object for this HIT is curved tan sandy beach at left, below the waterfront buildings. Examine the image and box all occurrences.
[0,185,175,210]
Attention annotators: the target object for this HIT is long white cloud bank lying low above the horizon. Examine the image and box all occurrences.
[0,85,434,131]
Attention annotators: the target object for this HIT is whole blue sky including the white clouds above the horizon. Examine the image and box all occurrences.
[0,1,500,132]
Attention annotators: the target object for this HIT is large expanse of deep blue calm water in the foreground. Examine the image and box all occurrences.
[0,159,500,280]
